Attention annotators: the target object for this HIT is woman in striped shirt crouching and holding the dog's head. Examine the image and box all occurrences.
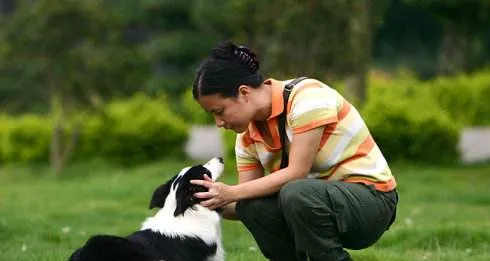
[192,42,398,261]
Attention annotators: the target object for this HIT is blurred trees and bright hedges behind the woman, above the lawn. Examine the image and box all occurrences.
[0,0,490,172]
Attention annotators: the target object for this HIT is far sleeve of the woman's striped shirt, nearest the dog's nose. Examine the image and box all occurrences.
[235,133,261,172]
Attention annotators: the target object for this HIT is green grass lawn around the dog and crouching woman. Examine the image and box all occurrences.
[0,158,490,261]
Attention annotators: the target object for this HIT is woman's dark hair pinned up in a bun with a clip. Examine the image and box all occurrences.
[192,41,264,99]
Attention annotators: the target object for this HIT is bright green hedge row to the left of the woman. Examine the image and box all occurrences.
[0,94,187,164]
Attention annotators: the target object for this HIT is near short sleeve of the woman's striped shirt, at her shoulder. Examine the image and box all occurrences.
[288,82,341,134]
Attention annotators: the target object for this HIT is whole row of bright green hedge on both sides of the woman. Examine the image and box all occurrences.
[0,70,490,164]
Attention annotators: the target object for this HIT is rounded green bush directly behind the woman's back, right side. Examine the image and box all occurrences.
[361,72,460,162]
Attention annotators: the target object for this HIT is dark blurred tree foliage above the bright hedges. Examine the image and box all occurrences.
[0,0,490,113]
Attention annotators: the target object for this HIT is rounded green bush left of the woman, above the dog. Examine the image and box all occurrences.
[81,94,187,163]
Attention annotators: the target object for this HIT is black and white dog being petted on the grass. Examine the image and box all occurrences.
[69,158,224,261]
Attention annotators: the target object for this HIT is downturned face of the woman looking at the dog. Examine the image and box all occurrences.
[197,87,255,133]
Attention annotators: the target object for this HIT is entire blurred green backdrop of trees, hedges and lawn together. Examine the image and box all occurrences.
[0,0,490,261]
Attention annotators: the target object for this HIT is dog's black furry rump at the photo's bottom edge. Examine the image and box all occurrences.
[70,235,152,261]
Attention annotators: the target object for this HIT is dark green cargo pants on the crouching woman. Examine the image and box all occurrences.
[236,179,398,261]
